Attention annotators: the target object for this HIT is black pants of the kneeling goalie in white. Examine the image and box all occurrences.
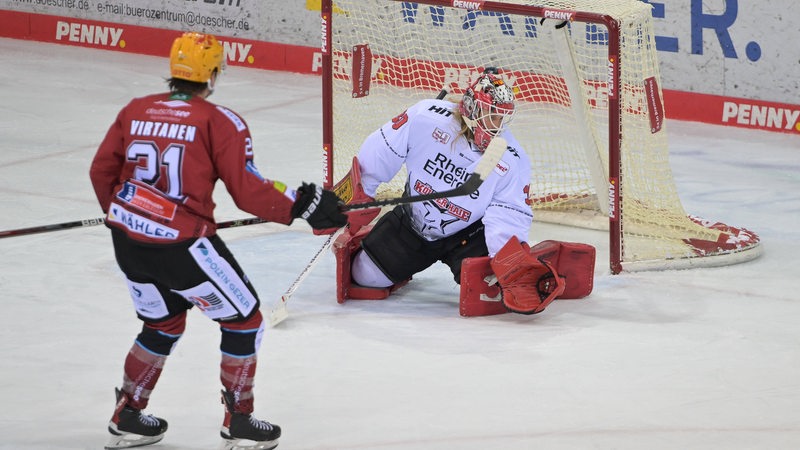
[361,205,489,283]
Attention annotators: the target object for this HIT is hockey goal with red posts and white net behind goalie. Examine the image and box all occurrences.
[322,0,762,273]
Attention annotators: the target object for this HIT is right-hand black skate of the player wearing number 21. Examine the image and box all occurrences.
[219,391,281,450]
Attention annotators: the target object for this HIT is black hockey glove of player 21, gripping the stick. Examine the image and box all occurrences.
[292,183,347,230]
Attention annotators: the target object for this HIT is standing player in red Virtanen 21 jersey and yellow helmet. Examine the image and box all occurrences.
[90,33,347,449]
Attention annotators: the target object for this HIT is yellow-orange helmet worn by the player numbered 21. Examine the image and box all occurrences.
[169,32,225,83]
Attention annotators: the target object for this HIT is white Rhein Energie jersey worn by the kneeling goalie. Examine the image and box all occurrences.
[358,99,533,256]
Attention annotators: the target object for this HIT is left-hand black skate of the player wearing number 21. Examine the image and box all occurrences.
[105,389,167,450]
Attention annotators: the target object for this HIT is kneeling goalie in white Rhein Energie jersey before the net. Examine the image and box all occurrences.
[334,68,594,316]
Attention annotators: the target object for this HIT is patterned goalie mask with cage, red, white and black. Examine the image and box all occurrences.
[459,69,514,151]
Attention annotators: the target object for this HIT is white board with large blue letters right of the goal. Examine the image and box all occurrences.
[648,0,800,104]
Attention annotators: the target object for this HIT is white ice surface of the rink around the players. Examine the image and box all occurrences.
[0,39,800,450]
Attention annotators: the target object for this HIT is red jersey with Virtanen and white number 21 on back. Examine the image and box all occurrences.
[90,93,296,243]
